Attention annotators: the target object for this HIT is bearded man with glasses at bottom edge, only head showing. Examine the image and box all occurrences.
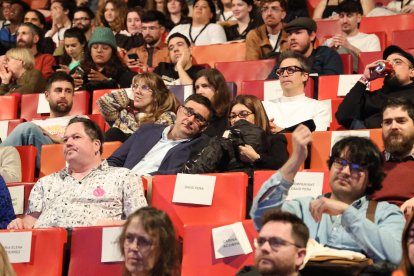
[237,211,309,276]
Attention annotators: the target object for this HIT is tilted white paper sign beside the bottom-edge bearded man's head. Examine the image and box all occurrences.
[212,222,253,259]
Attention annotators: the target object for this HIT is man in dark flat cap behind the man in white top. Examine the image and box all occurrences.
[268,17,343,80]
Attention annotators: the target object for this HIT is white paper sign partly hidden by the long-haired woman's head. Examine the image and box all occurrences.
[101,227,124,263]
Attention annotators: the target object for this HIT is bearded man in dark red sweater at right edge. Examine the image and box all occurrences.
[373,98,414,209]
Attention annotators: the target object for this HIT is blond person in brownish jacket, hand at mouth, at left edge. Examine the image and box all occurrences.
[0,48,46,95]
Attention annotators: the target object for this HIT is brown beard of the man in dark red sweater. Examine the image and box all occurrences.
[382,130,414,157]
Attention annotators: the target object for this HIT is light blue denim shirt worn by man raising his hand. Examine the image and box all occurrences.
[250,172,405,264]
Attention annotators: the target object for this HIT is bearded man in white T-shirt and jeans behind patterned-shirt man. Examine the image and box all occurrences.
[1,72,74,169]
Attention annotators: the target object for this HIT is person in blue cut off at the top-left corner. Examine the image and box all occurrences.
[0,0,30,55]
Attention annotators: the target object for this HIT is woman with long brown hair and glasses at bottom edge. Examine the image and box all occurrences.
[119,207,180,276]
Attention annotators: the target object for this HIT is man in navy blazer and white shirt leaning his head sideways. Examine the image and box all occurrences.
[108,94,213,175]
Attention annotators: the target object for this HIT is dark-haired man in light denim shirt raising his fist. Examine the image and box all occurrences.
[250,125,405,264]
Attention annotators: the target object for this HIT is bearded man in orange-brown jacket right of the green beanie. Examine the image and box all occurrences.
[128,10,170,72]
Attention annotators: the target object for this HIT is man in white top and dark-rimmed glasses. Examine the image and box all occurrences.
[263,51,331,132]
